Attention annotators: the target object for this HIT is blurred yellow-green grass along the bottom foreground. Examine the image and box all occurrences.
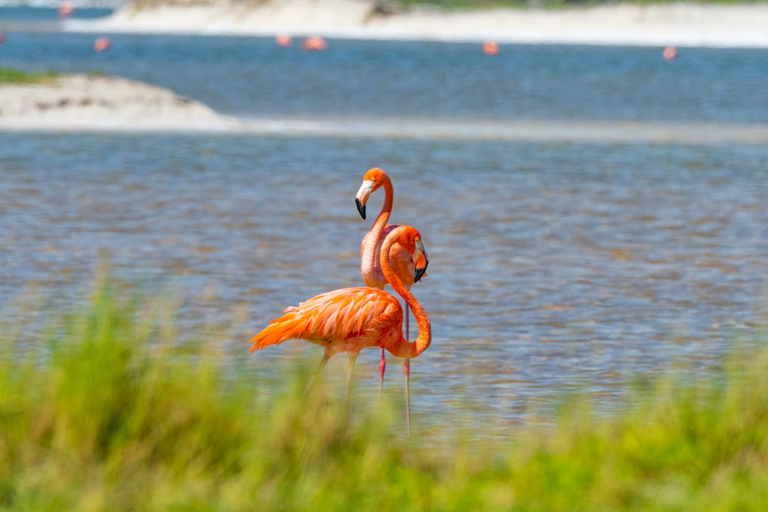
[0,276,768,512]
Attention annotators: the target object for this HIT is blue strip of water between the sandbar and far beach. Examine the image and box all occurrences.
[0,16,768,122]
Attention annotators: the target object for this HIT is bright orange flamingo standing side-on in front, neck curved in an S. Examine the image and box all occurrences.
[251,226,432,434]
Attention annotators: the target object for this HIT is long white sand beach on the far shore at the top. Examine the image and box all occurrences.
[68,0,768,47]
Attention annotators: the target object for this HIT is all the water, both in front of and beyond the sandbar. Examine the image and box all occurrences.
[0,8,768,428]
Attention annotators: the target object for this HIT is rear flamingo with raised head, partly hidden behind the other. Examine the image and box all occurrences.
[355,167,422,396]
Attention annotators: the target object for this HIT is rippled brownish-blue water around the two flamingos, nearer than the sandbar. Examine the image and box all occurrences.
[0,134,768,421]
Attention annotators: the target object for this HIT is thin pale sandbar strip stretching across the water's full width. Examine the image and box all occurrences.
[0,112,768,145]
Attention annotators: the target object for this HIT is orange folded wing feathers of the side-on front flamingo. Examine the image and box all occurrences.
[251,287,403,353]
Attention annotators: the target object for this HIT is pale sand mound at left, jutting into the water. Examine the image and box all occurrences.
[0,75,233,130]
